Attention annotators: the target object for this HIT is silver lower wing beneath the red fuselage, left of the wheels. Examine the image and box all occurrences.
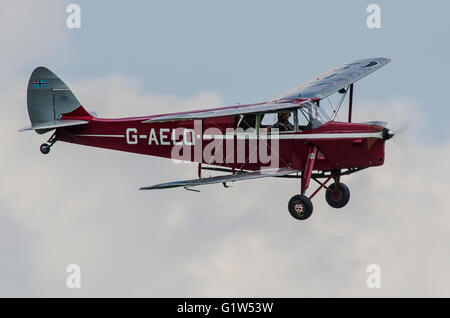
[140,168,297,190]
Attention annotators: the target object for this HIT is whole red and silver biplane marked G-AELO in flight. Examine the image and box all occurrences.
[19,58,394,220]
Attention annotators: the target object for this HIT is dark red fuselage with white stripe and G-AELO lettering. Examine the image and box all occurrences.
[57,107,385,171]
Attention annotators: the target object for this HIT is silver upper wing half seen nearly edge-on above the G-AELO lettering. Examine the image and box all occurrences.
[143,100,310,123]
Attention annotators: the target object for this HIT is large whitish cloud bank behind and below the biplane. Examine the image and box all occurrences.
[0,67,450,297]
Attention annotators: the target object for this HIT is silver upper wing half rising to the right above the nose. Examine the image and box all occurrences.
[271,57,391,101]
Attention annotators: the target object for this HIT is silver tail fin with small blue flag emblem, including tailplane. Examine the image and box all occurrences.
[20,66,92,134]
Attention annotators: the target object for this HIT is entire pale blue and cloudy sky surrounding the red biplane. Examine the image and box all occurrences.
[0,0,450,297]
